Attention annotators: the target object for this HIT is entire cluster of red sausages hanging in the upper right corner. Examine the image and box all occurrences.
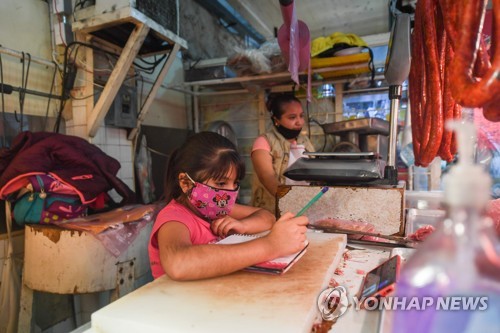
[409,0,500,166]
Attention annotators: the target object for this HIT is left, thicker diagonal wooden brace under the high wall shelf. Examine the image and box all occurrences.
[87,23,149,137]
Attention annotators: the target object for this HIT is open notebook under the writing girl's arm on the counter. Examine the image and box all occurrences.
[217,234,309,275]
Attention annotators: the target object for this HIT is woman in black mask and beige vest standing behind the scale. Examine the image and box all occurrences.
[251,93,315,214]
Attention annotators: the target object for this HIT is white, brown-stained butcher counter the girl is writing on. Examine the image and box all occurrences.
[75,231,402,333]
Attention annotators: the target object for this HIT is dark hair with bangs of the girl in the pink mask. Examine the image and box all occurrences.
[164,132,245,203]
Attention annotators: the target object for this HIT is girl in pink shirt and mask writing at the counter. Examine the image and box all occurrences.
[148,132,308,280]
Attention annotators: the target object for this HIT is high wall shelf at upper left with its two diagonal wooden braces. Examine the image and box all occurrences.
[73,6,187,139]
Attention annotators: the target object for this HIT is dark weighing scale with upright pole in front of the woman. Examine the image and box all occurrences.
[284,14,410,186]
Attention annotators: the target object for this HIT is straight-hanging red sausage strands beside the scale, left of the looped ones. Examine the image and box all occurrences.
[409,0,453,166]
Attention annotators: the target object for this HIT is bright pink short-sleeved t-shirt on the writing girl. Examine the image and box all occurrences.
[148,200,217,279]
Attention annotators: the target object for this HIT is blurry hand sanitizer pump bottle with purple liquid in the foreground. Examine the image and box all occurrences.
[392,121,500,333]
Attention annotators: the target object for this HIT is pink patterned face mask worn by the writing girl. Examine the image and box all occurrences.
[186,173,239,221]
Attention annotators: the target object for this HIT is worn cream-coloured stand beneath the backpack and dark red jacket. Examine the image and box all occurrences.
[18,221,153,333]
